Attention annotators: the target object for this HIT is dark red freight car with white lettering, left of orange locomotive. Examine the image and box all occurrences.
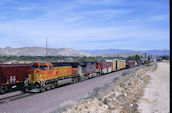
[0,64,32,93]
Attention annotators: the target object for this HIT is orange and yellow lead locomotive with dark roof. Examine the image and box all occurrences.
[24,62,79,92]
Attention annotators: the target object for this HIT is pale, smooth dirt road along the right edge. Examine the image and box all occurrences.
[139,62,170,113]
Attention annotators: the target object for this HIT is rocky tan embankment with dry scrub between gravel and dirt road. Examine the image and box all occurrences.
[63,64,157,113]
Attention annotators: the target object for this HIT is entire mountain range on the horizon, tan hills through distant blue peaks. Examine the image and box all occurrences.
[0,47,169,57]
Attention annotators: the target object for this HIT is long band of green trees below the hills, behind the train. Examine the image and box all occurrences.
[0,55,170,63]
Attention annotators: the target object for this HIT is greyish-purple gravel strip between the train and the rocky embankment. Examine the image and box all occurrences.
[0,69,134,113]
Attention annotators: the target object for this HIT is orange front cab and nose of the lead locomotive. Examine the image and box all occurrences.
[24,62,55,92]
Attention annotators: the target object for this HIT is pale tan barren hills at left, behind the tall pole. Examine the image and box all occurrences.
[0,47,94,57]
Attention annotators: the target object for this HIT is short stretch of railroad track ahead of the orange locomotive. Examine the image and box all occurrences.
[0,93,33,104]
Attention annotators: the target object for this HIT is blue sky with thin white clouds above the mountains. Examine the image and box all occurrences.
[0,0,169,50]
